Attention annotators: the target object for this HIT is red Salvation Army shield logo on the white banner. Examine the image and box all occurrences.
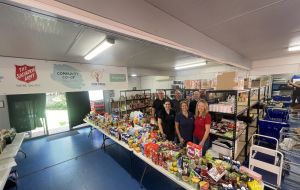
[15,65,37,83]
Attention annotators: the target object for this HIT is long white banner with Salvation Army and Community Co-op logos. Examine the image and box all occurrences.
[0,57,128,94]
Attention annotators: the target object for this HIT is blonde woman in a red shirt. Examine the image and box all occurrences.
[193,100,211,155]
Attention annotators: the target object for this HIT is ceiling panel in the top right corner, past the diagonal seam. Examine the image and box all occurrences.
[203,0,300,60]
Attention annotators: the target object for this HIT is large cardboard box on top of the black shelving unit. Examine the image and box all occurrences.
[216,72,244,90]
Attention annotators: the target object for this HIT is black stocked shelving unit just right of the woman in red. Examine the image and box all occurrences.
[207,87,267,159]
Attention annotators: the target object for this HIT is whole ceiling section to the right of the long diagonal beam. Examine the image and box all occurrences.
[145,0,300,60]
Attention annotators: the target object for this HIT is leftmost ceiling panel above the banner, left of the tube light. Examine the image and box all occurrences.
[0,4,80,59]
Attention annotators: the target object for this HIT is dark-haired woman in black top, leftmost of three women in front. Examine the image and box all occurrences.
[158,100,176,141]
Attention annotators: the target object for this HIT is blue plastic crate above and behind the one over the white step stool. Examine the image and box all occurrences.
[264,107,289,123]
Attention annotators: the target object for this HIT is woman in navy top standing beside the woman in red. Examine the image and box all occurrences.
[175,101,194,144]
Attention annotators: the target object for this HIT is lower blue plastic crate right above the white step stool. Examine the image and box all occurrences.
[258,120,290,141]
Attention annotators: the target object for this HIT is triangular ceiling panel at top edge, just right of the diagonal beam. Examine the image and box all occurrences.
[146,0,278,31]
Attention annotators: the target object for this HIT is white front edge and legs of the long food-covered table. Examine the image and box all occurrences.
[84,119,195,190]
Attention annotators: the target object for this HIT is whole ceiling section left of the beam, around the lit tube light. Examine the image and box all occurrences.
[0,3,216,70]
